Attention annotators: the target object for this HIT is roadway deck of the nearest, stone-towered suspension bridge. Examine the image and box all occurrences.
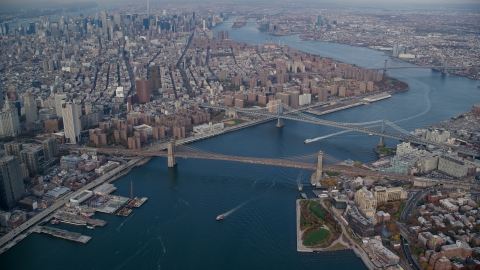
[94,148,413,181]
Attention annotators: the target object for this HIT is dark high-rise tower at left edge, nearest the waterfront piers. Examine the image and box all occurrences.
[0,157,25,209]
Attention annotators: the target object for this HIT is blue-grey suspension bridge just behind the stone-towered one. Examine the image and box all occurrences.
[183,101,478,157]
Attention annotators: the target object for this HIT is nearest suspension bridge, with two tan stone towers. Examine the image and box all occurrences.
[96,141,413,181]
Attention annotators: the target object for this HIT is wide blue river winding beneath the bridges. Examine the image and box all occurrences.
[0,15,480,270]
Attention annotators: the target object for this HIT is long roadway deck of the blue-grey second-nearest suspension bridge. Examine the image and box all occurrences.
[184,101,478,156]
